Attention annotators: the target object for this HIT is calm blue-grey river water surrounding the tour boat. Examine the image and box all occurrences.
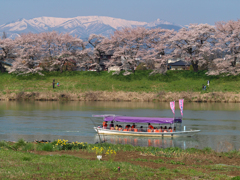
[0,101,240,151]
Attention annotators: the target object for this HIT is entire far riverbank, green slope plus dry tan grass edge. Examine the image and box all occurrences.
[0,71,240,102]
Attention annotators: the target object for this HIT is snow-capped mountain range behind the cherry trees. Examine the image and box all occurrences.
[0,16,181,38]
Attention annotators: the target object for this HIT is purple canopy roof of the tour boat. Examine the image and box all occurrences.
[93,115,182,124]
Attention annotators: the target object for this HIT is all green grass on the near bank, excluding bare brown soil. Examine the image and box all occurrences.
[0,139,240,179]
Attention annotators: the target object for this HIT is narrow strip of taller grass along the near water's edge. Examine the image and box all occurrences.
[0,139,240,158]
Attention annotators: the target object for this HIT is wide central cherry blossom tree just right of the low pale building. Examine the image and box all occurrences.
[101,27,153,75]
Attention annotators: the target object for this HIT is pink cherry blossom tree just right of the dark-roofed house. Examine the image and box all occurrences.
[170,24,215,71]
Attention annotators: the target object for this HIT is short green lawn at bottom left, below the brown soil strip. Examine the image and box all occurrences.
[0,149,232,179]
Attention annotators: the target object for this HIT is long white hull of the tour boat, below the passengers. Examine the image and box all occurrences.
[94,127,200,137]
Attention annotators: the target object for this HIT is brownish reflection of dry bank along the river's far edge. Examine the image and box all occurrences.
[0,101,240,111]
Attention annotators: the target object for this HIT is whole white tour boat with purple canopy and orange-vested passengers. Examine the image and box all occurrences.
[93,114,200,137]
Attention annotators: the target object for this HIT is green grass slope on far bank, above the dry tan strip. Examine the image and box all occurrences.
[0,70,240,94]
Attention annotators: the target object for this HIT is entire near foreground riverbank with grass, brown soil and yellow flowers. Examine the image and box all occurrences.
[0,140,240,180]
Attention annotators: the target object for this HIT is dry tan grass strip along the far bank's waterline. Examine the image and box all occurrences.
[0,91,240,103]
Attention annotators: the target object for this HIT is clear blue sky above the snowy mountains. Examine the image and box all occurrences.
[0,0,240,26]
